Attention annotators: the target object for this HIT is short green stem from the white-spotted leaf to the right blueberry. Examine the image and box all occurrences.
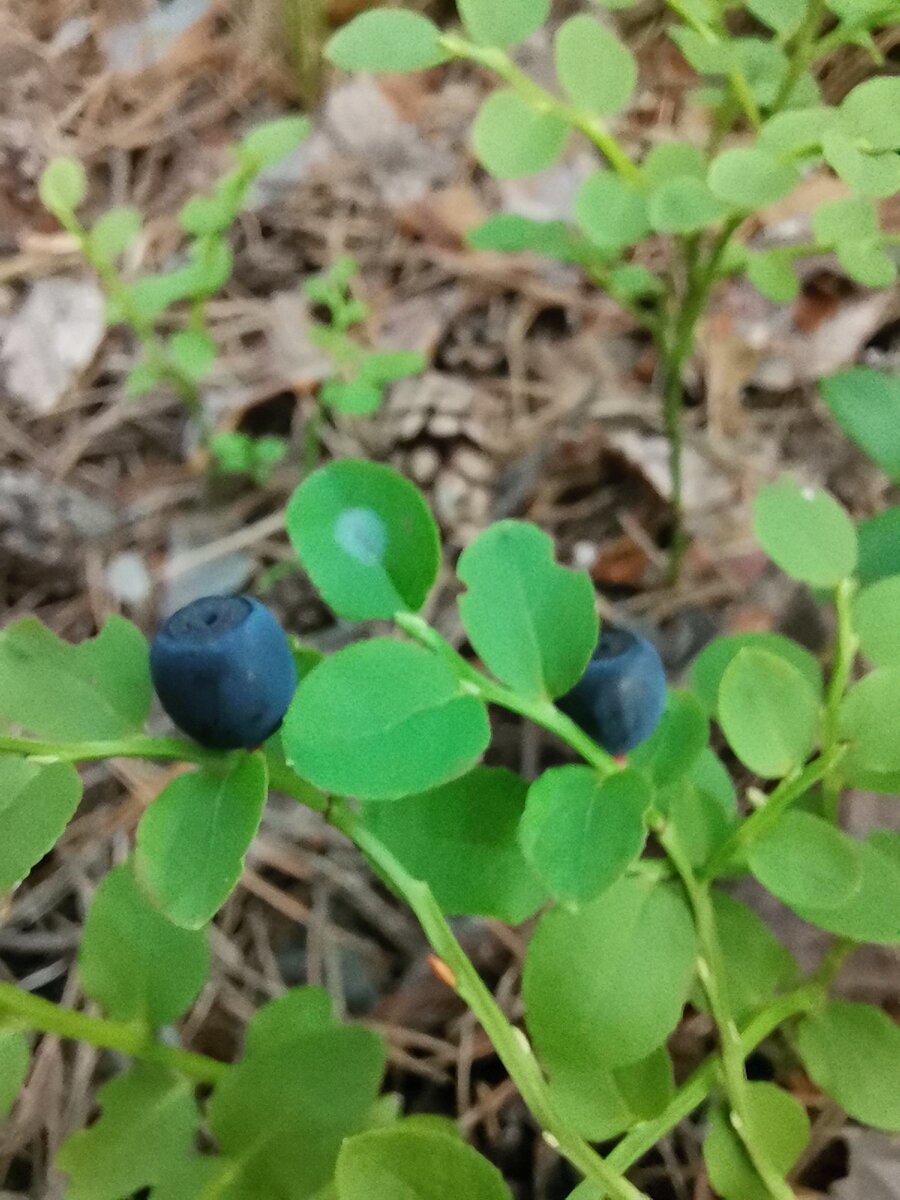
[394,612,619,776]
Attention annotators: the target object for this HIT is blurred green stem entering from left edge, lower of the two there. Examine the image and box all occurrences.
[0,983,230,1084]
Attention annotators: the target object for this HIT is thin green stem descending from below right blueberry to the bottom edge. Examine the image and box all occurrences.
[660,828,793,1200]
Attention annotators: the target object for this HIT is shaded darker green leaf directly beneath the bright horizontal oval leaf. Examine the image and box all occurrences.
[362,767,546,925]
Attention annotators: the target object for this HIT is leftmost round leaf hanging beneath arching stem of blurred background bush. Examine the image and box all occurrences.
[472,90,569,179]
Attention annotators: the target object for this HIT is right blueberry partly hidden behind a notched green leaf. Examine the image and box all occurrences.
[557,626,666,755]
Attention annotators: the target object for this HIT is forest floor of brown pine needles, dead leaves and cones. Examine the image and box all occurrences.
[0,0,900,1200]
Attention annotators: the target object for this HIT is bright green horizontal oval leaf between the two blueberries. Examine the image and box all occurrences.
[282,637,491,800]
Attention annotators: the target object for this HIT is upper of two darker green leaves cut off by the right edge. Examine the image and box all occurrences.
[818,367,900,480]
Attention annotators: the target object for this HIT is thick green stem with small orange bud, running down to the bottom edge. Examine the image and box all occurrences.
[330,806,646,1200]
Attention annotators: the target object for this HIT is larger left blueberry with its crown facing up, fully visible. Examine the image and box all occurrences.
[150,596,296,750]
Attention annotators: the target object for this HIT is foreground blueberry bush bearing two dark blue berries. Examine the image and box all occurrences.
[0,453,900,1200]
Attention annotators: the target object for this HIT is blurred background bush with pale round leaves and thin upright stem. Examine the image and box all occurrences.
[328,0,900,574]
